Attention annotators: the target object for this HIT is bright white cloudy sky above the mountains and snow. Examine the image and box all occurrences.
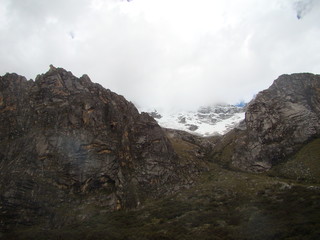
[0,0,320,109]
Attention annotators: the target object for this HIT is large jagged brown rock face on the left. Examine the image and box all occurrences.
[0,66,190,230]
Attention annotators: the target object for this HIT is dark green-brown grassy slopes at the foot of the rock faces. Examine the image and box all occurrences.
[4,135,320,240]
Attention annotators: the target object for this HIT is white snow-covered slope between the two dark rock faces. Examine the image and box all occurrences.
[140,105,245,136]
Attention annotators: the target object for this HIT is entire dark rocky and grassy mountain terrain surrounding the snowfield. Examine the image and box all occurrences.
[0,66,320,240]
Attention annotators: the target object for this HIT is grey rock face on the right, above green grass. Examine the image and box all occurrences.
[214,73,320,172]
